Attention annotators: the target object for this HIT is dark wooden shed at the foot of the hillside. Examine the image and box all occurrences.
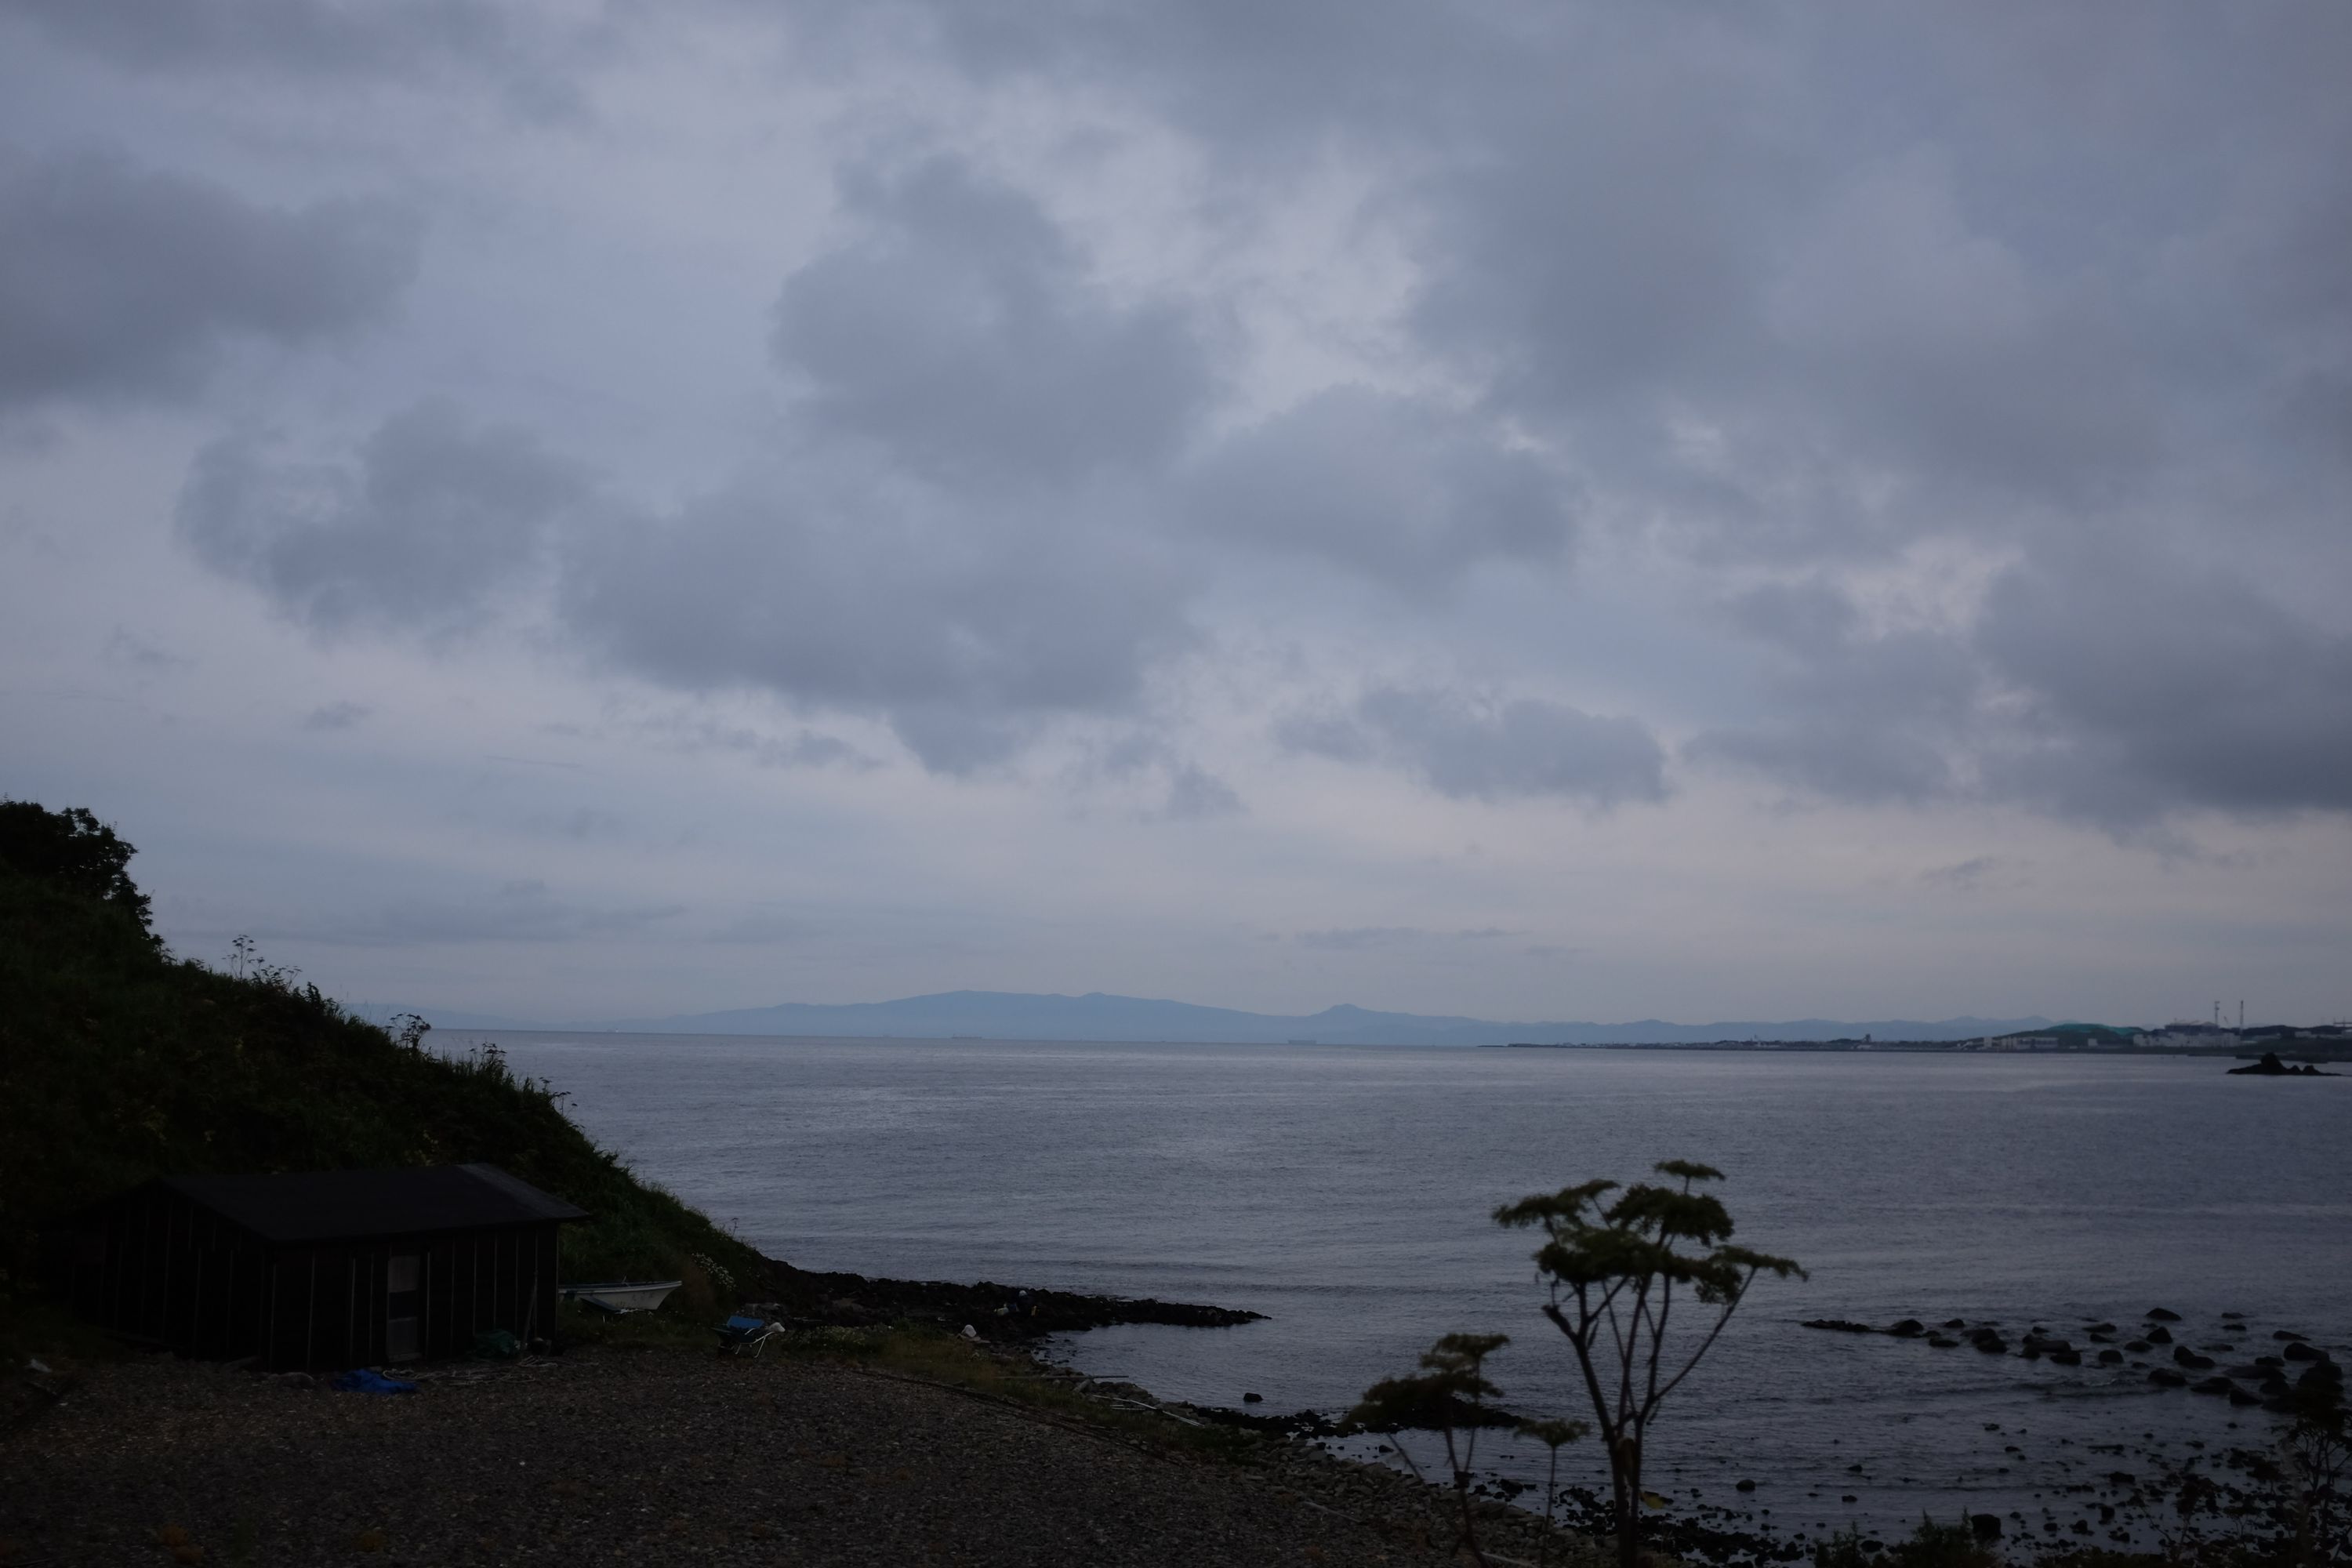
[59,1163,588,1368]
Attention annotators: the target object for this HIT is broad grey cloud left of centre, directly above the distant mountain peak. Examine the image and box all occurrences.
[562,463,1190,771]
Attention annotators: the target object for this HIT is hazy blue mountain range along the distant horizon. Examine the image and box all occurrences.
[353,992,2051,1046]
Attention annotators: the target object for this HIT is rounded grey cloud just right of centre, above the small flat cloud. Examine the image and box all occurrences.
[1188,388,1569,590]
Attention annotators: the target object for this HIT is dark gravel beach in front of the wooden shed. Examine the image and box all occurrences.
[0,1349,1599,1568]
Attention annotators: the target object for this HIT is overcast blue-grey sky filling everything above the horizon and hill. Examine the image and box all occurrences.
[0,0,2352,1022]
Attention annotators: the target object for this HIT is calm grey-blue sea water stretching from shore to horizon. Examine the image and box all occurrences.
[435,1032,2352,1535]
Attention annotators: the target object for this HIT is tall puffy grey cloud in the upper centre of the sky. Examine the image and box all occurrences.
[774,158,1209,485]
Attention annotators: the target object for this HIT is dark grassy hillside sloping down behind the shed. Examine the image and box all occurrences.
[0,801,760,1345]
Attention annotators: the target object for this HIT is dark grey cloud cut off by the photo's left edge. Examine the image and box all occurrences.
[0,151,416,409]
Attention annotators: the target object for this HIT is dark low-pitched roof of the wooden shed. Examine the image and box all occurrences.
[158,1163,588,1241]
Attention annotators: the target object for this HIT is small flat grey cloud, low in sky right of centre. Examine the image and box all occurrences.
[1277,687,1665,806]
